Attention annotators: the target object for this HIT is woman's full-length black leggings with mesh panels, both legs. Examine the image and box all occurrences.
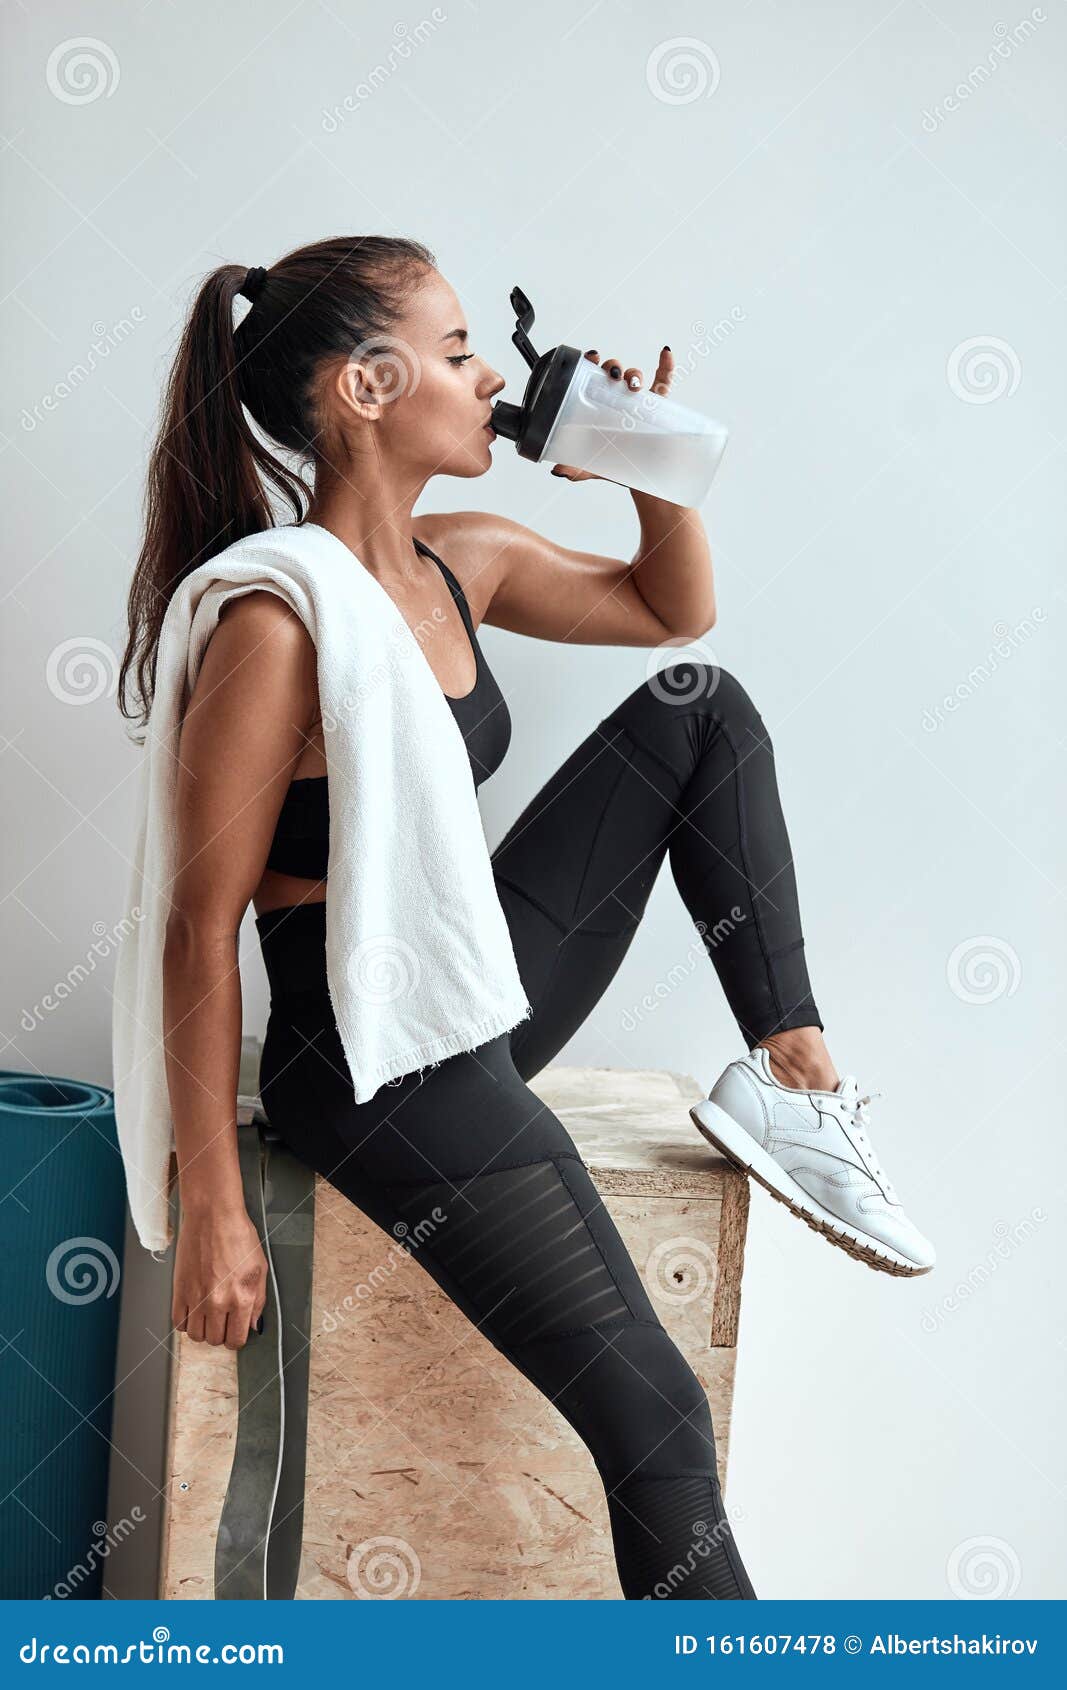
[257,662,822,1599]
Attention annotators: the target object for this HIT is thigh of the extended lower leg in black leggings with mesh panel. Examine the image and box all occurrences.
[260,1009,658,1365]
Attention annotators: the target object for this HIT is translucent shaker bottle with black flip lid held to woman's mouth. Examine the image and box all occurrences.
[492,287,729,505]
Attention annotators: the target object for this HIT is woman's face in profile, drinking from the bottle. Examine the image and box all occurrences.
[362,270,504,482]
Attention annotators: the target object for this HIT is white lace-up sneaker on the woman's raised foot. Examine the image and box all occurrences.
[690,1044,937,1274]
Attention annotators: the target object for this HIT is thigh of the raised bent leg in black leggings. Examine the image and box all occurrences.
[492,686,697,1078]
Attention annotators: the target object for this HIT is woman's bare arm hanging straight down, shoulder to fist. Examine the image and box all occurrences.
[162,592,318,1347]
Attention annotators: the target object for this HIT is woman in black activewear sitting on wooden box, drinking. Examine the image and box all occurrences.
[123,237,932,1599]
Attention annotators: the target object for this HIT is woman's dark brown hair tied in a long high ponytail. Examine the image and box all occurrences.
[118,235,436,744]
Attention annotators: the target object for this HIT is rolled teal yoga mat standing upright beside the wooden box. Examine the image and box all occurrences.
[0,1068,128,1600]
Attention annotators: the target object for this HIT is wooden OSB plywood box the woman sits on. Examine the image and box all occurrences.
[161,1068,747,1600]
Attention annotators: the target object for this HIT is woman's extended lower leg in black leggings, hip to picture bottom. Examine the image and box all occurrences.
[260,1006,751,1597]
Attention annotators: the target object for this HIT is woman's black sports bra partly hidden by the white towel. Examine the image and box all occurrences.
[265,539,511,880]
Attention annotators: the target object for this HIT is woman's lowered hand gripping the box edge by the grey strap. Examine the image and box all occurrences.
[171,1208,267,1350]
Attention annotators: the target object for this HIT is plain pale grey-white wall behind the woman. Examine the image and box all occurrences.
[0,0,1067,1597]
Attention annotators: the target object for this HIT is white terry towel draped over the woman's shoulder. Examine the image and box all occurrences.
[112,522,533,1251]
